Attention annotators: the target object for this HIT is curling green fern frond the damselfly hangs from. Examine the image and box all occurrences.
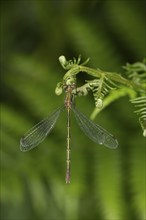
[58,56,146,137]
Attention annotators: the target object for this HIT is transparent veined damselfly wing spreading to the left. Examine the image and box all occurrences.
[20,106,64,152]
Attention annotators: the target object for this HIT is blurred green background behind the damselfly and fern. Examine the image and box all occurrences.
[0,0,146,220]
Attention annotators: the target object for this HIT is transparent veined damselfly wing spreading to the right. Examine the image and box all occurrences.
[72,106,118,149]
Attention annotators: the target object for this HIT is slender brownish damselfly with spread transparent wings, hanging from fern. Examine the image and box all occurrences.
[20,83,118,183]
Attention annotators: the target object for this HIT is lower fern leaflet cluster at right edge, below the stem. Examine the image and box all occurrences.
[131,96,146,137]
